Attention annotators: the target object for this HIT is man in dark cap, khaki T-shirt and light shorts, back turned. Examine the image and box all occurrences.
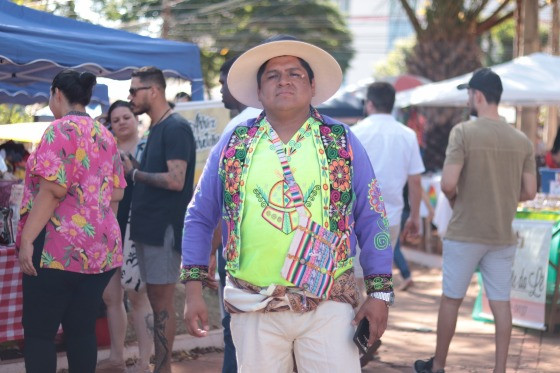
[414,68,537,373]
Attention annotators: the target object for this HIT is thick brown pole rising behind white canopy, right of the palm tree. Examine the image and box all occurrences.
[517,0,540,145]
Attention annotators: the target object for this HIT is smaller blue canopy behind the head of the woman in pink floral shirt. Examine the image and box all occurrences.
[0,81,109,111]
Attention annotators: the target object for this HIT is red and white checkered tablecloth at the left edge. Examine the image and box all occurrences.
[0,246,23,342]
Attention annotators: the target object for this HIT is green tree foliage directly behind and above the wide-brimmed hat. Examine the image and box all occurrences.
[95,0,354,93]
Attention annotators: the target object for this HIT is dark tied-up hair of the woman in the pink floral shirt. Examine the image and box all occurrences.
[51,69,97,106]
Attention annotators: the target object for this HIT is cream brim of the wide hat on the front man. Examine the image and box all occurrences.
[227,40,342,109]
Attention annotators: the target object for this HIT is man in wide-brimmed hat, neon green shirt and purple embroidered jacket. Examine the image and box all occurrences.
[182,36,393,372]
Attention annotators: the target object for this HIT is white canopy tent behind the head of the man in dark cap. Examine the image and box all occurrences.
[395,53,560,107]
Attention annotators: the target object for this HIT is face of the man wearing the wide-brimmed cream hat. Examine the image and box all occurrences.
[258,56,315,113]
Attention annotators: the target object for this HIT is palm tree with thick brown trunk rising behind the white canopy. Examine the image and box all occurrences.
[400,0,516,169]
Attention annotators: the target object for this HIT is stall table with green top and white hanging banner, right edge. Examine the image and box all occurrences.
[473,194,560,332]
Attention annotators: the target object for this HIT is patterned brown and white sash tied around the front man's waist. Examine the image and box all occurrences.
[224,269,359,313]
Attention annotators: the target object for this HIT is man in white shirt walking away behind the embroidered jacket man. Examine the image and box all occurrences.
[351,82,425,289]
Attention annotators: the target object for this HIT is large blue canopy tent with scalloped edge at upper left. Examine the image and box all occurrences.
[0,0,203,100]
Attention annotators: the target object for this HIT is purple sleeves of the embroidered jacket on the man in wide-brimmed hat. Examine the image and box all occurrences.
[182,109,393,292]
